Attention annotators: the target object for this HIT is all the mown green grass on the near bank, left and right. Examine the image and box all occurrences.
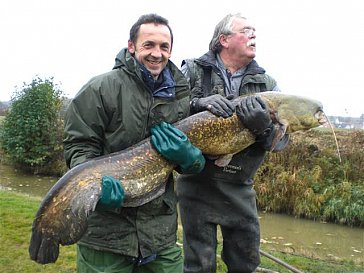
[0,190,364,273]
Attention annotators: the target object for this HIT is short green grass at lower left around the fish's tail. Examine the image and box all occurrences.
[0,190,76,273]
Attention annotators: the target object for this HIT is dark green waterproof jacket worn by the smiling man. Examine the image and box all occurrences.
[64,49,190,257]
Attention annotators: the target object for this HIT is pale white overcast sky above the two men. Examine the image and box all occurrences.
[0,0,364,117]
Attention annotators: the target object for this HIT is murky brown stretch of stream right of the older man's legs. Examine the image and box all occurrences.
[260,211,364,262]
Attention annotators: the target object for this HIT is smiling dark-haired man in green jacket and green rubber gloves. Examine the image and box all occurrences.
[64,14,205,273]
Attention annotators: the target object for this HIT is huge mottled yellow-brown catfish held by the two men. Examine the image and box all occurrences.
[29,92,326,264]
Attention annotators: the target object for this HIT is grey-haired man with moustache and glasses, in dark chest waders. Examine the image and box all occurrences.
[177,14,288,273]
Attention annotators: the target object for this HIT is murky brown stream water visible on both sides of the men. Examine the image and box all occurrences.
[0,164,364,263]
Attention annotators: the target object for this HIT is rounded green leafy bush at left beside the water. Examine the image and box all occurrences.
[0,78,63,172]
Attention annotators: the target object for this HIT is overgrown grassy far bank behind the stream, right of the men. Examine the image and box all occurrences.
[255,128,364,226]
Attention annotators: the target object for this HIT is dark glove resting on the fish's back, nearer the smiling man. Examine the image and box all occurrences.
[192,94,234,118]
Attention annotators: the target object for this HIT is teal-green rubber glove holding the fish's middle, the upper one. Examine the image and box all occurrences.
[151,122,205,173]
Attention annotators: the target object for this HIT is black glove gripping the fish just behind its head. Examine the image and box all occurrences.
[236,96,273,138]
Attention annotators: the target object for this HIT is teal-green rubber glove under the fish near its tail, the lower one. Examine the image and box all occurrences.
[96,176,125,211]
